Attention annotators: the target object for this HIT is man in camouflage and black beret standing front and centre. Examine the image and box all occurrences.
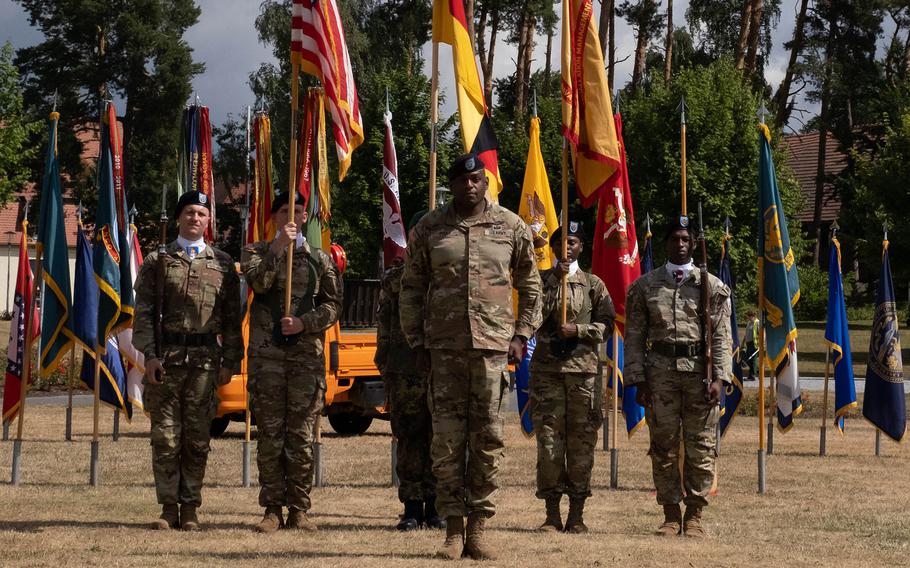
[399,154,541,559]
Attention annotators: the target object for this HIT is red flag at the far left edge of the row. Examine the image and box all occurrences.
[3,221,41,422]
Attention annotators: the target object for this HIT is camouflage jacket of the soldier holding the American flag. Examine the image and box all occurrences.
[240,241,342,357]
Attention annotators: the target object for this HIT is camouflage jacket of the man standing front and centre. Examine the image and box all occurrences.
[399,200,541,351]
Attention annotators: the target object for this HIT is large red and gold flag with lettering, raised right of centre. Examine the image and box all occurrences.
[562,0,619,203]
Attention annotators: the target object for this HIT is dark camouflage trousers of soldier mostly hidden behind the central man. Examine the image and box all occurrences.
[383,372,436,503]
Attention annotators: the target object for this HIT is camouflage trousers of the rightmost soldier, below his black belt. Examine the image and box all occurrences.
[645,368,720,506]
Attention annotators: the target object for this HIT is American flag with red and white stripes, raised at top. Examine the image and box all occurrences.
[291,0,363,180]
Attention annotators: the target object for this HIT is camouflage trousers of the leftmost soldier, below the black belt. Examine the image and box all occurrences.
[143,366,218,507]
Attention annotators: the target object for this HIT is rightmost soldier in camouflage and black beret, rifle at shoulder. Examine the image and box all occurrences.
[624,217,732,537]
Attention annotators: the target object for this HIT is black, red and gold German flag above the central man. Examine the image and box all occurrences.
[433,0,502,200]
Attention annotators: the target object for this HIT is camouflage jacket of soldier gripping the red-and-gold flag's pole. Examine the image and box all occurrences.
[531,268,616,373]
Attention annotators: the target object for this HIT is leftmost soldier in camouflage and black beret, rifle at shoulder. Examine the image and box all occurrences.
[133,191,243,530]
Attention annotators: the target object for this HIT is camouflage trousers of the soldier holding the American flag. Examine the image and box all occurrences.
[249,352,325,511]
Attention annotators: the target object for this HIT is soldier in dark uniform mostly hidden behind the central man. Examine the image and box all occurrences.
[375,211,445,531]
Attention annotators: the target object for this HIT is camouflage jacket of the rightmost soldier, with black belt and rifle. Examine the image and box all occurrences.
[623,266,733,385]
